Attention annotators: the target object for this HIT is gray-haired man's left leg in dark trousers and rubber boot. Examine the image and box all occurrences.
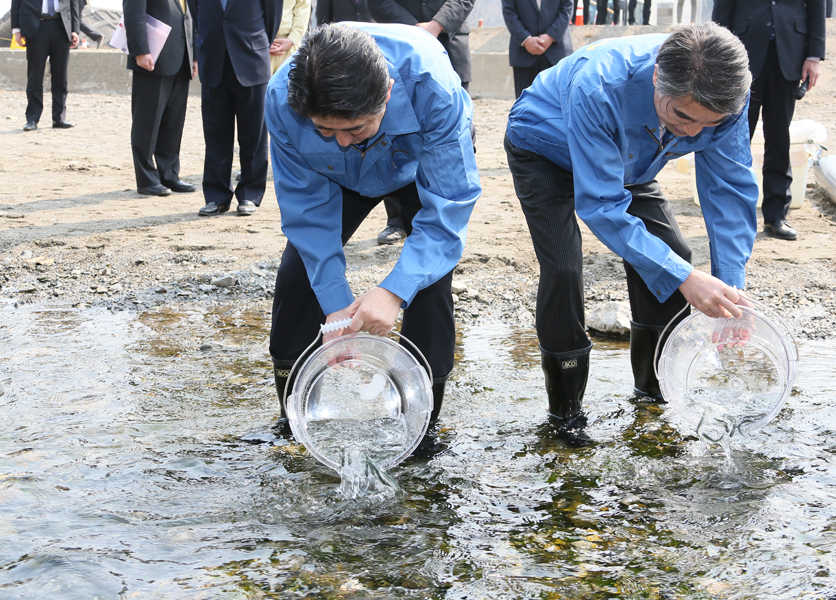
[505,137,592,445]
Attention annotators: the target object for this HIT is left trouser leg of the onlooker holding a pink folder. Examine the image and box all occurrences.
[131,69,167,189]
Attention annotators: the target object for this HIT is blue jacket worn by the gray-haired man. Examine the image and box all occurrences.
[507,34,758,301]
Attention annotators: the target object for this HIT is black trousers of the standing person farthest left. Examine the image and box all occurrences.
[26,17,70,123]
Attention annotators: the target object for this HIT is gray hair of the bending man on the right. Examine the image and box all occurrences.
[656,23,752,115]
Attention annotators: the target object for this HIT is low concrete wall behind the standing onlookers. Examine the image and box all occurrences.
[0,25,665,98]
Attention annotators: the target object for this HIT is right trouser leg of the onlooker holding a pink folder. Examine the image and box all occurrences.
[154,67,189,184]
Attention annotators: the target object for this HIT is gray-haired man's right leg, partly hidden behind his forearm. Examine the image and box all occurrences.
[624,181,691,400]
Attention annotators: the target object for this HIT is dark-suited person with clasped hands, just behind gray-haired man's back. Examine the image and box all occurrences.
[502,0,574,98]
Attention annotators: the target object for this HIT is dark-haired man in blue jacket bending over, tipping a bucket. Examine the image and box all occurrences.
[266,23,481,438]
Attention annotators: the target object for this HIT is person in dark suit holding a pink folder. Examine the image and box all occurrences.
[122,0,197,196]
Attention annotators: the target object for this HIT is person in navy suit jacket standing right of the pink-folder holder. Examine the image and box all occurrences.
[194,0,283,216]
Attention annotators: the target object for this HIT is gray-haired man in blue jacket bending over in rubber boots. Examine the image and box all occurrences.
[505,23,758,445]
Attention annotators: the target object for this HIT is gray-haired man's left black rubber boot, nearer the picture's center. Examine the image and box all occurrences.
[540,345,594,448]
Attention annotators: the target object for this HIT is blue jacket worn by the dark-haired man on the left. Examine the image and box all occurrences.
[265,23,482,314]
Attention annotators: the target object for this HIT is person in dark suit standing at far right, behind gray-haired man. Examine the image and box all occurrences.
[712,0,825,240]
